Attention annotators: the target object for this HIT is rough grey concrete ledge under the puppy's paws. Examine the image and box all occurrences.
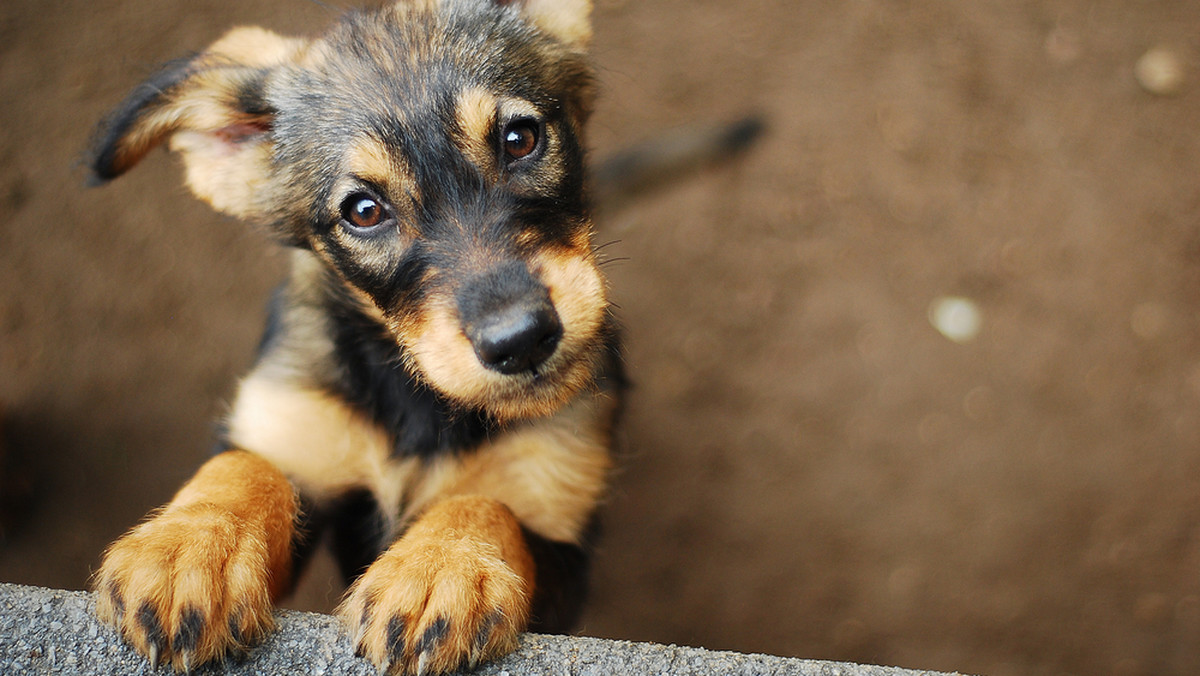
[0,584,960,676]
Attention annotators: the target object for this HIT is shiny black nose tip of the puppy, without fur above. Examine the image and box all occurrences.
[467,303,563,376]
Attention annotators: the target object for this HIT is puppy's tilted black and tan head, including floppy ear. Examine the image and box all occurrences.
[94,0,607,419]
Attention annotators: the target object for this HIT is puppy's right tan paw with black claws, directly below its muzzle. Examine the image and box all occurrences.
[340,497,530,676]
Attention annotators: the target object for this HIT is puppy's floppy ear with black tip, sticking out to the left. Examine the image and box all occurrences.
[90,28,307,216]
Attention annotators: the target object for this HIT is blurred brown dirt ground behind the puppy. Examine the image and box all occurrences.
[0,0,1200,676]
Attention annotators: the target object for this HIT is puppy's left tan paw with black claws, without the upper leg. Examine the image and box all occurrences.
[92,504,272,671]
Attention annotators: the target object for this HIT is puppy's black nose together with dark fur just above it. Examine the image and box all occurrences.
[458,264,563,376]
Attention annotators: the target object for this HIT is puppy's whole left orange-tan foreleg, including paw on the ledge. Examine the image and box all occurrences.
[92,450,298,671]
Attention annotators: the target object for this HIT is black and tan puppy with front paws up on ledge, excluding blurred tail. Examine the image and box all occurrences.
[91,0,620,674]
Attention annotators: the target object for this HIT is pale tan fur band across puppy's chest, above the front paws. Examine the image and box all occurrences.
[228,355,616,542]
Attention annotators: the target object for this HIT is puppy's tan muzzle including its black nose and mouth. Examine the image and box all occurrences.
[398,255,608,420]
